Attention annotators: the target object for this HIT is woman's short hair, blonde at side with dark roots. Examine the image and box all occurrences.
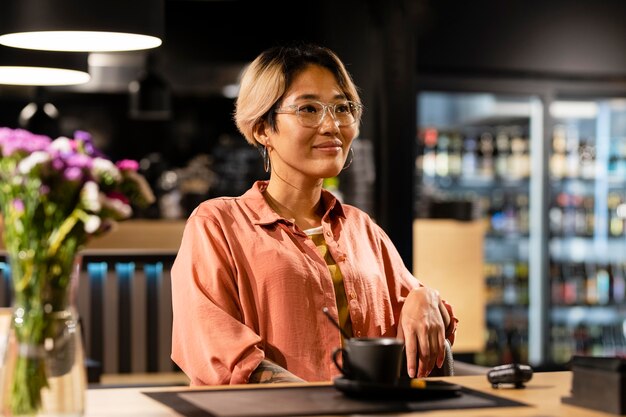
[235,45,361,146]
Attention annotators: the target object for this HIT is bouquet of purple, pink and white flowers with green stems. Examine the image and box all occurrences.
[0,128,154,415]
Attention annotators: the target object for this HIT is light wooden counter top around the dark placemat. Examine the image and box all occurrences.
[85,372,613,417]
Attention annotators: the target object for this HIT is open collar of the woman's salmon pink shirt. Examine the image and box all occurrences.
[241,181,346,225]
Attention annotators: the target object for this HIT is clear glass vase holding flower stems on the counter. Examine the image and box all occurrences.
[0,255,87,417]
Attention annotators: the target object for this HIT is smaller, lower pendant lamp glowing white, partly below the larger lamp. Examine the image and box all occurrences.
[0,46,90,86]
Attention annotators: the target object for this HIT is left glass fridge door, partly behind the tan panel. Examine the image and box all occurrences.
[414,91,543,366]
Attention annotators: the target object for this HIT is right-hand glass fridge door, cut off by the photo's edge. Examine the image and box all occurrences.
[549,99,626,365]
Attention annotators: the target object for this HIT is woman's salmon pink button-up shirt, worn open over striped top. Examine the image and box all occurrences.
[172,181,457,385]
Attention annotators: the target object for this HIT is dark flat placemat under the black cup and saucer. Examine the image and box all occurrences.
[143,385,526,417]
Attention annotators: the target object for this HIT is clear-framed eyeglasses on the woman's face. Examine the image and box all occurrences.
[274,101,363,127]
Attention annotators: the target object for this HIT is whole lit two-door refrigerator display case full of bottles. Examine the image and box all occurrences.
[414,91,626,369]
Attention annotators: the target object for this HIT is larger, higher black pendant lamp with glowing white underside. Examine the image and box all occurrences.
[0,0,164,52]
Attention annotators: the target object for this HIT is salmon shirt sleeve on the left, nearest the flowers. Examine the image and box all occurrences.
[171,214,265,385]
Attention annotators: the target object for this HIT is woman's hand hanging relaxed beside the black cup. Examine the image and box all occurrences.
[398,287,450,378]
